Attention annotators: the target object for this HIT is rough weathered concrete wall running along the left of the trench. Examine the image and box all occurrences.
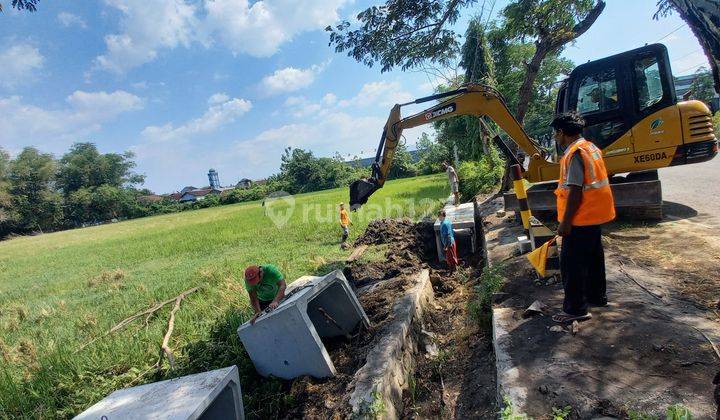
[350,270,434,420]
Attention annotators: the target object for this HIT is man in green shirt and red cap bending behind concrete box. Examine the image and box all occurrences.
[245,264,286,324]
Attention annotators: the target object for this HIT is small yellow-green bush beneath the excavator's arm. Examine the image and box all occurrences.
[458,149,504,201]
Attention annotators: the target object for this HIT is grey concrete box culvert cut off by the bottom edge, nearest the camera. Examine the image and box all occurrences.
[75,366,245,420]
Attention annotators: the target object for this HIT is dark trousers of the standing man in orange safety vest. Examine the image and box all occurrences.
[560,225,607,315]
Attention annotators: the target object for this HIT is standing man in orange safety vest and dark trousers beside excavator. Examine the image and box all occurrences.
[551,112,615,323]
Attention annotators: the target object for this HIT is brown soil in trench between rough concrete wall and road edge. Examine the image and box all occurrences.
[403,269,497,419]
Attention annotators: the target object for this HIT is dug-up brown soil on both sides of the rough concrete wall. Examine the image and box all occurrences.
[286,219,497,419]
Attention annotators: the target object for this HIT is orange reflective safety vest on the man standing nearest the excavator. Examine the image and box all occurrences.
[555,138,615,226]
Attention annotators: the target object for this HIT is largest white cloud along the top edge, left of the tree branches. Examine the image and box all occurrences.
[95,0,347,74]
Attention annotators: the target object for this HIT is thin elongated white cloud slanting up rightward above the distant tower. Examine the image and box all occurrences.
[141,94,252,142]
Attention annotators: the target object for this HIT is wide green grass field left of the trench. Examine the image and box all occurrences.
[0,175,447,418]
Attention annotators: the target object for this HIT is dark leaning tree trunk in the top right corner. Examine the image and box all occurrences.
[654,0,720,93]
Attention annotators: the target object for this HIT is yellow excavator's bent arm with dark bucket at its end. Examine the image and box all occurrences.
[350,84,557,210]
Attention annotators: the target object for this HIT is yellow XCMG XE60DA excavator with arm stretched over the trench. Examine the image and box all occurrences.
[350,44,718,219]
